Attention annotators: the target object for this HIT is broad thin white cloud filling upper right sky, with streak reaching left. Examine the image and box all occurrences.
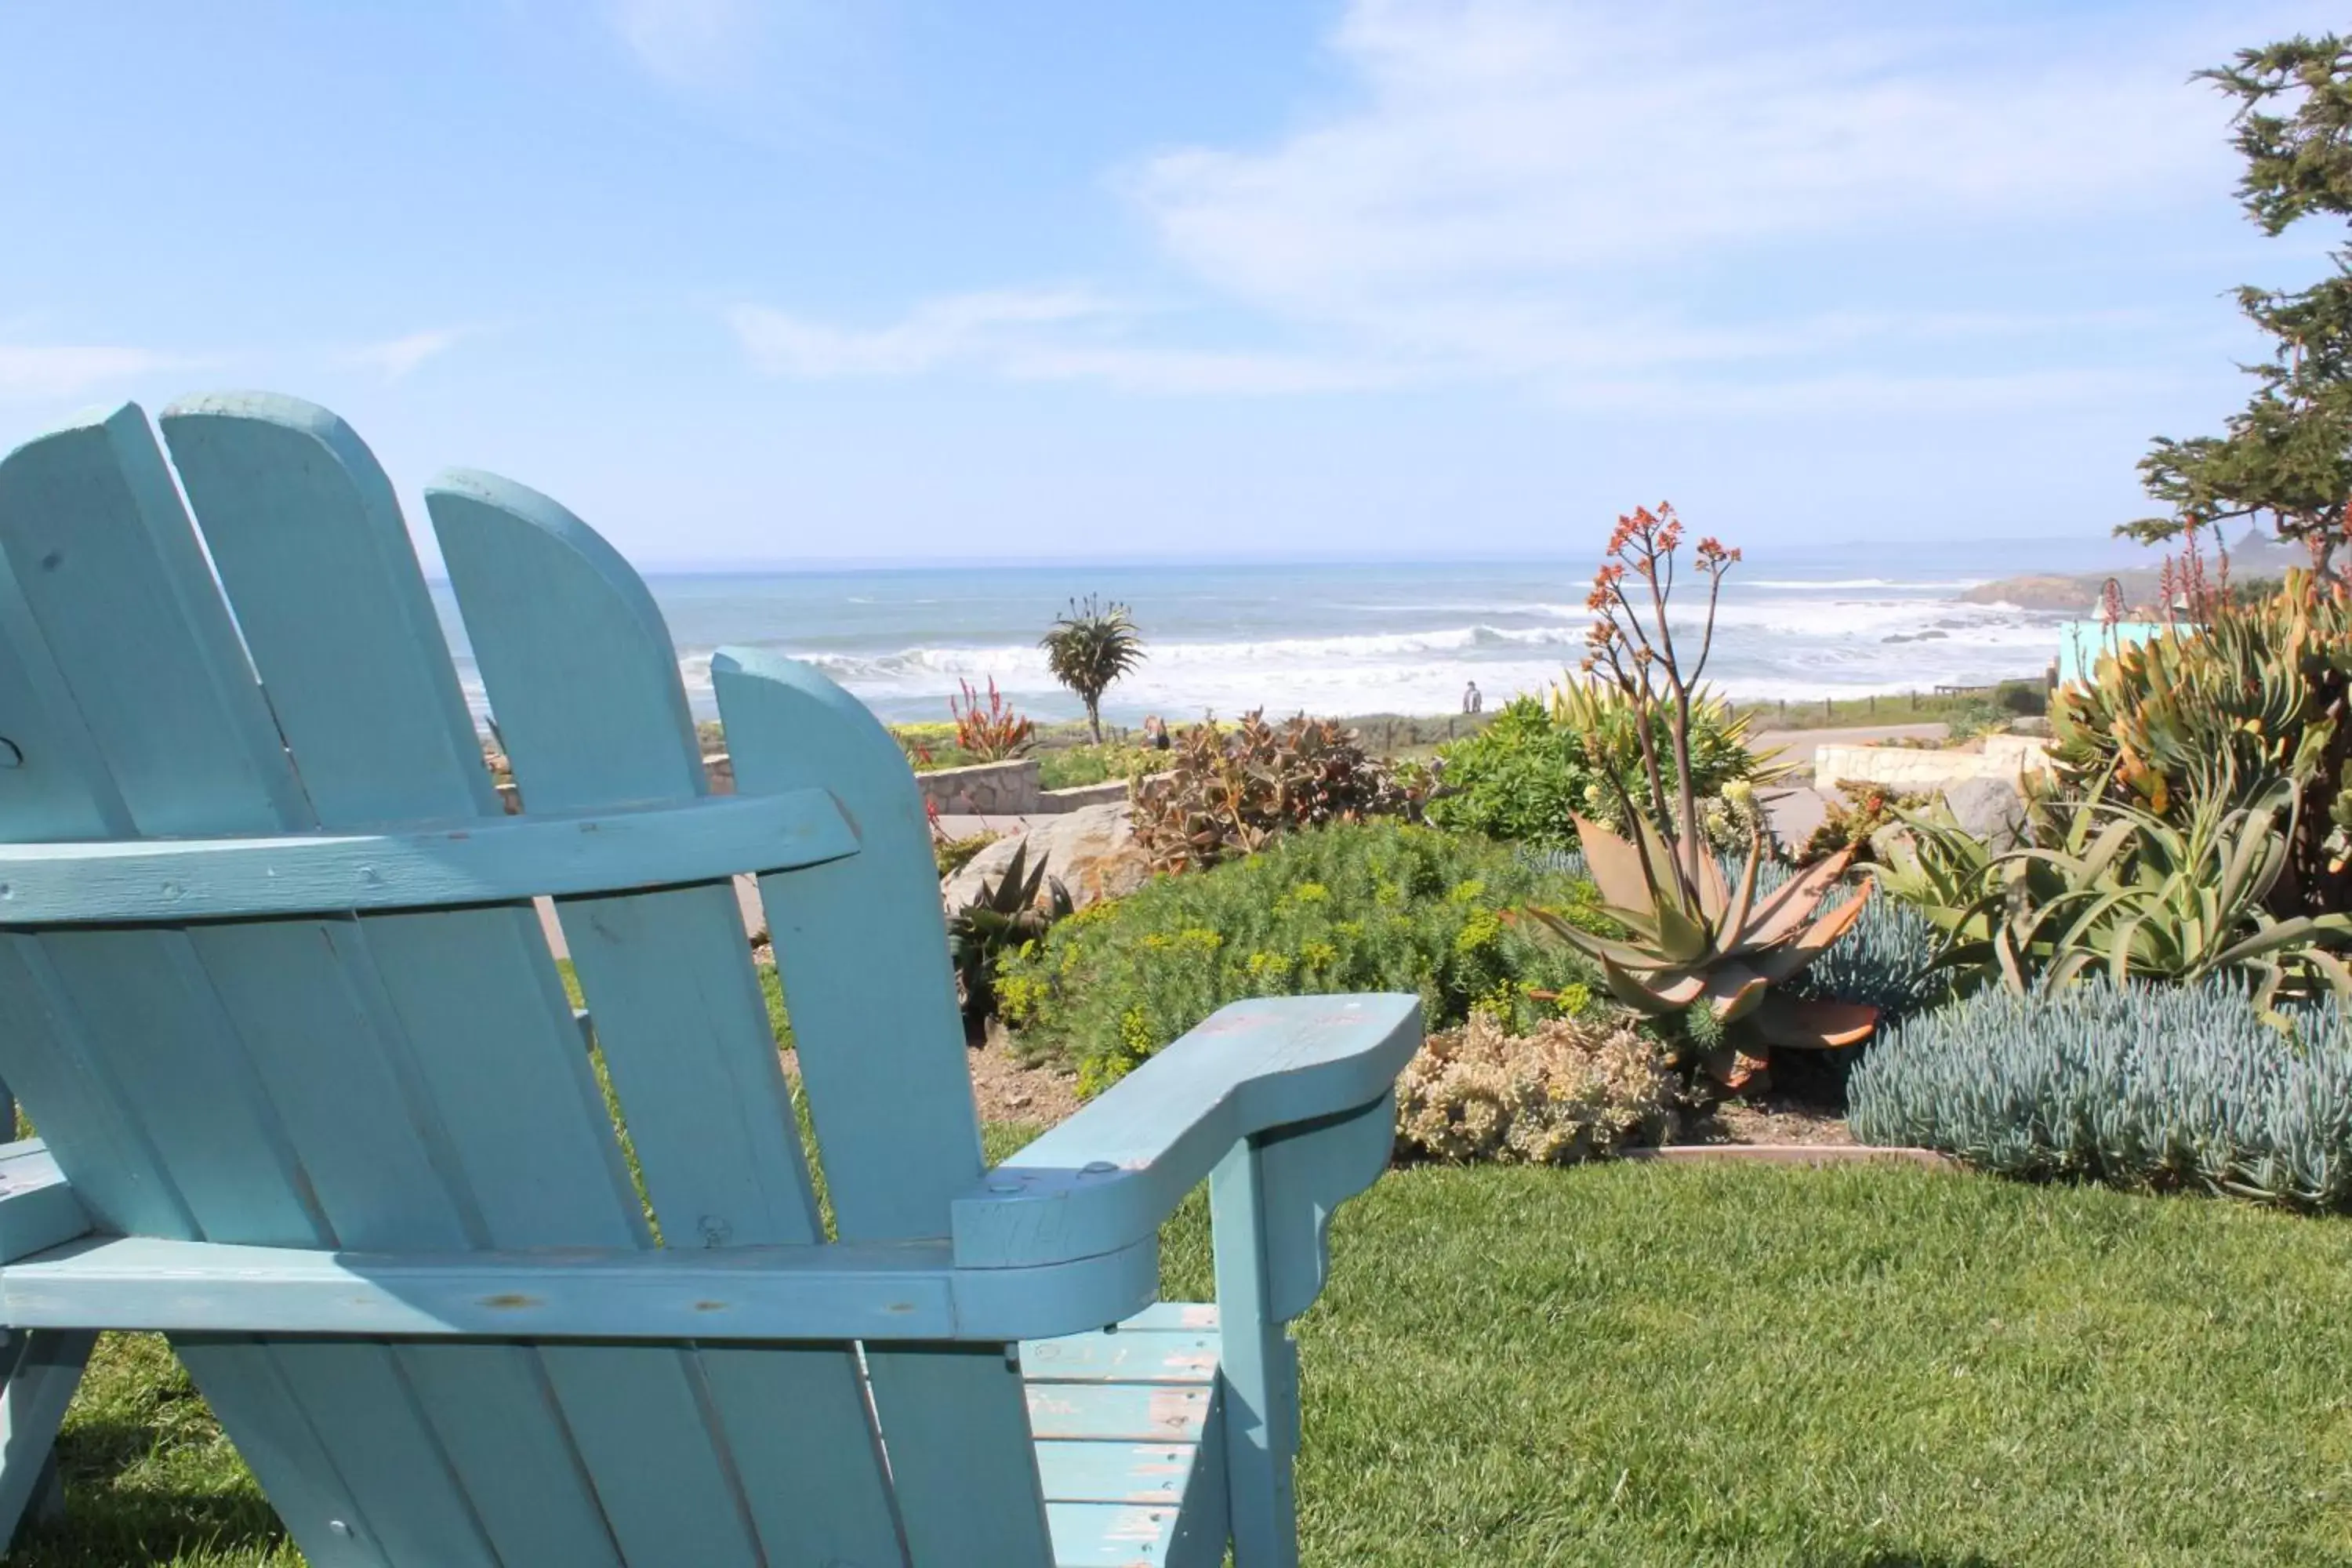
[731,0,2317,412]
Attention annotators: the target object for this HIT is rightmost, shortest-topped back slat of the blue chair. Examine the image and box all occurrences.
[710,652,1051,1568]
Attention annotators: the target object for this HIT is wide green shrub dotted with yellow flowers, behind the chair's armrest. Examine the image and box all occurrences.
[997,822,1597,1093]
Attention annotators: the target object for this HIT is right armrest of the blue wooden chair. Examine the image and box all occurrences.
[953,994,1421,1269]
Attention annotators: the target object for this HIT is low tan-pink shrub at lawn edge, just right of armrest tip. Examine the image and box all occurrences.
[1397,1011,1677,1166]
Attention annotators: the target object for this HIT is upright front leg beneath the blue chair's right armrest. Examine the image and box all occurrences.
[1209,1142,1298,1568]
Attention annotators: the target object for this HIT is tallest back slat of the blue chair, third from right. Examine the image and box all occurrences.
[162,397,800,1568]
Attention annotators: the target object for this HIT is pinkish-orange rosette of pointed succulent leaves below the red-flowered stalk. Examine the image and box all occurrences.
[1526,818,1879,1088]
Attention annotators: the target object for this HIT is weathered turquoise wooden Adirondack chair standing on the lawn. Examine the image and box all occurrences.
[0,395,1418,1568]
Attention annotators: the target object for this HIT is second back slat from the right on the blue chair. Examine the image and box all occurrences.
[426,473,903,1566]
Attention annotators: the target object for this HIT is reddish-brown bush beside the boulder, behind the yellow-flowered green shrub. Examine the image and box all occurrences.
[1134,713,1421,872]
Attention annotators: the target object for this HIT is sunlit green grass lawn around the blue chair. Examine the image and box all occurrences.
[12,1161,2352,1568]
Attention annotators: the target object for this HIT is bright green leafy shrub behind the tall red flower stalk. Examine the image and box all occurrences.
[1430,682,1762,848]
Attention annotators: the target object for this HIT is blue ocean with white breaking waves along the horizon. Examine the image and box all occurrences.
[435,541,2117,724]
